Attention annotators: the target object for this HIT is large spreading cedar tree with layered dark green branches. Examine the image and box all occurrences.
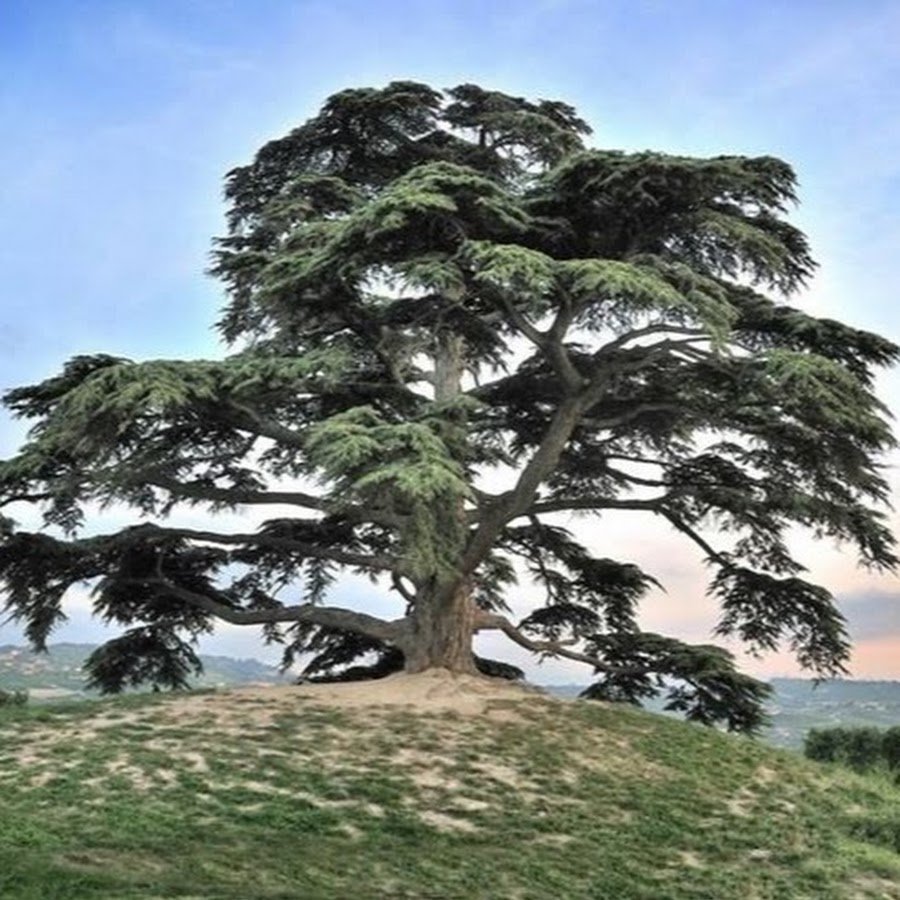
[0,82,897,731]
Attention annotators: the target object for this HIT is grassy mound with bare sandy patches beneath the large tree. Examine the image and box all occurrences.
[0,692,900,900]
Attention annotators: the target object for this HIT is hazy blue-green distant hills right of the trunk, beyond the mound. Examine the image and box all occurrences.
[547,678,900,749]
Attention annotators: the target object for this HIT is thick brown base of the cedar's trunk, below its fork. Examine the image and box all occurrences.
[402,582,478,675]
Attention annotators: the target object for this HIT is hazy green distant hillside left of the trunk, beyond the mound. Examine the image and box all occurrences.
[0,644,290,700]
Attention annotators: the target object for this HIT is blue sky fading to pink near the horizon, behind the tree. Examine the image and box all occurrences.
[0,0,900,678]
